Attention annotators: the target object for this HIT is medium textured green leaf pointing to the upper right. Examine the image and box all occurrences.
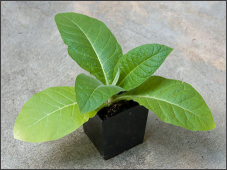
[115,44,173,91]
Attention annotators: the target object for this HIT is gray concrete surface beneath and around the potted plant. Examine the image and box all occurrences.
[1,2,226,169]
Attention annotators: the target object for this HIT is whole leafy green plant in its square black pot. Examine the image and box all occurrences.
[14,12,216,159]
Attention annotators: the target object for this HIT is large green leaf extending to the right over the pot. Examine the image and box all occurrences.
[115,76,216,131]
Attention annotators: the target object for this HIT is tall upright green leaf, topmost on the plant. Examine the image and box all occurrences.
[55,12,123,85]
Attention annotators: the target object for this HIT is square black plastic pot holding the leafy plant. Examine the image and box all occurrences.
[83,101,148,160]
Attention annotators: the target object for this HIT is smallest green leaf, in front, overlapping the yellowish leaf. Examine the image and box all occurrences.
[75,74,124,113]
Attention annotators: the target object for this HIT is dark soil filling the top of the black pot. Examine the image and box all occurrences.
[97,100,138,120]
